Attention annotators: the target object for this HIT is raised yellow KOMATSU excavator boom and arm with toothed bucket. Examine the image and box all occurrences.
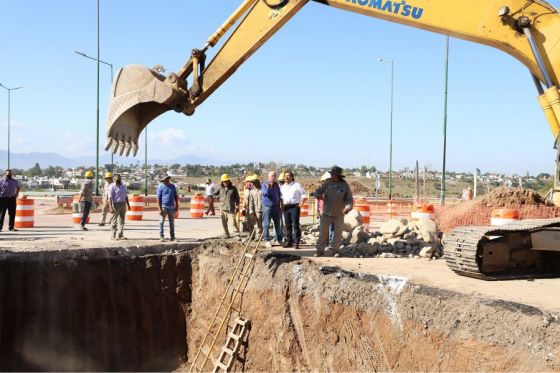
[106,0,560,176]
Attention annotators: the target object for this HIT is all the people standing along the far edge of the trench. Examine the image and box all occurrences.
[0,166,353,256]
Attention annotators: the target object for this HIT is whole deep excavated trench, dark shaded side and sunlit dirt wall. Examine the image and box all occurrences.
[0,241,560,371]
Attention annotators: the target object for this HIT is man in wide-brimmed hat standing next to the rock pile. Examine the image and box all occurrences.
[313,166,353,257]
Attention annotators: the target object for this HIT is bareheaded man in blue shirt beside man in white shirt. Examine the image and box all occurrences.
[261,171,282,248]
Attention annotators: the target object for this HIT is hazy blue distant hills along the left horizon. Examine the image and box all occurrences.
[0,150,225,170]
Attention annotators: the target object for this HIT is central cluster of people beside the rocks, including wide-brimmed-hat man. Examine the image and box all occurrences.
[205,166,353,256]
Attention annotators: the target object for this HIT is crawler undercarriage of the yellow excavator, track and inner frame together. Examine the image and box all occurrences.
[444,219,560,280]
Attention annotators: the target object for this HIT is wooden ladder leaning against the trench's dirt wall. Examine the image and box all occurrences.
[189,230,263,373]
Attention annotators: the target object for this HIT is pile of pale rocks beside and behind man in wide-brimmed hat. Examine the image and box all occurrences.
[302,210,443,258]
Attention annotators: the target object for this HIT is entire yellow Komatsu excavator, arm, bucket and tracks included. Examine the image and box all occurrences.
[105,0,560,280]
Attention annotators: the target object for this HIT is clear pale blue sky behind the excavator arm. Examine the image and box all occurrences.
[0,0,560,174]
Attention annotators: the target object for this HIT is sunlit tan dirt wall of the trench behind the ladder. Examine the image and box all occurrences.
[185,248,560,371]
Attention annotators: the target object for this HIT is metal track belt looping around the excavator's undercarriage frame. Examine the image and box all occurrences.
[444,219,560,281]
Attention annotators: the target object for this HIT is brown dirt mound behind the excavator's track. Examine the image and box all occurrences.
[436,187,560,232]
